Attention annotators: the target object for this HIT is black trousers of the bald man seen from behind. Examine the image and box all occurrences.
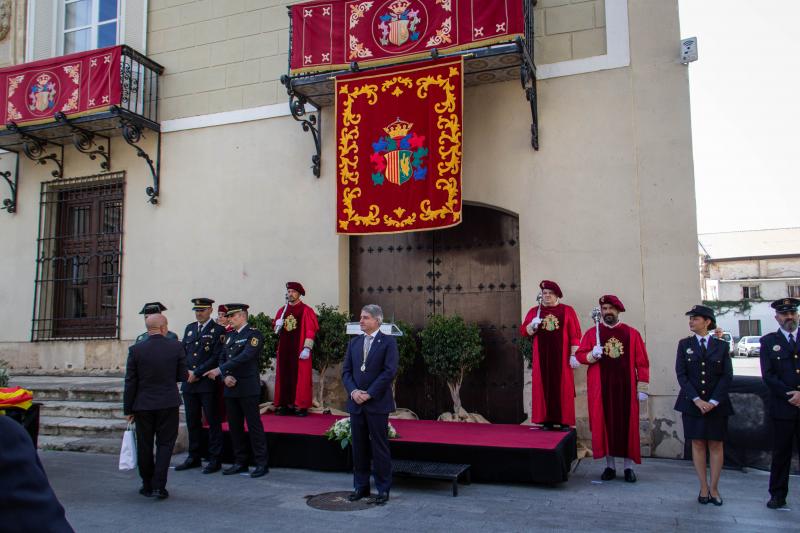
[133,407,178,489]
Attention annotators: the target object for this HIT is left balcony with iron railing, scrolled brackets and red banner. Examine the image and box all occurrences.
[0,45,164,213]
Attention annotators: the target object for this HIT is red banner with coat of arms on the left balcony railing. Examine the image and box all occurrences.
[0,46,122,127]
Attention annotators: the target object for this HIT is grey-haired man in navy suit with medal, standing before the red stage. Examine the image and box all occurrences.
[342,305,399,505]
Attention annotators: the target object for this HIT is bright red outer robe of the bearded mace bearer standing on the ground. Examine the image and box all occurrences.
[575,323,650,463]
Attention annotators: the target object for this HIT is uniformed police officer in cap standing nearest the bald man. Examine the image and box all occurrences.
[175,298,225,474]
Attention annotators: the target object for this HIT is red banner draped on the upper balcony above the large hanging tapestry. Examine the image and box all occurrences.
[289,0,529,74]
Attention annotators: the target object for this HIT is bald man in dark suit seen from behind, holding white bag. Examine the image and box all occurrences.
[123,315,187,500]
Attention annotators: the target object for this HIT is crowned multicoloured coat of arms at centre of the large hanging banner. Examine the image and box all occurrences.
[370,118,428,185]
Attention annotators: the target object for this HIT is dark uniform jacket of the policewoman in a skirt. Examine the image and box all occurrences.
[675,335,733,417]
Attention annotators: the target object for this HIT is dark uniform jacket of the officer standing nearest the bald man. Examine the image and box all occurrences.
[181,320,225,393]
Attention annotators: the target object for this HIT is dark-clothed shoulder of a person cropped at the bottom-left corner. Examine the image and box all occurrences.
[0,416,73,533]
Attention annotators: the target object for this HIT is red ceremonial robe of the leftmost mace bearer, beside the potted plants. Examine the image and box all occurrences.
[274,302,319,409]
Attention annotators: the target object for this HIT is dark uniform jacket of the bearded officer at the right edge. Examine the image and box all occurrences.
[760,331,800,420]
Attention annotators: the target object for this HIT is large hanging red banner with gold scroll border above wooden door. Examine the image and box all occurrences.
[336,57,464,235]
